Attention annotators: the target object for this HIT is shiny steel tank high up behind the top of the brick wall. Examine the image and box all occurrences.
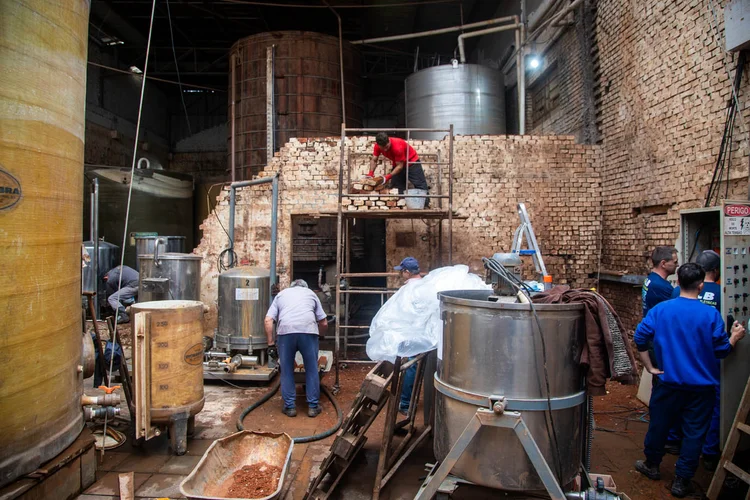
[406,64,505,139]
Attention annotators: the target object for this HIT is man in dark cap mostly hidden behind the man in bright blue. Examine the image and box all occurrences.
[666,250,721,470]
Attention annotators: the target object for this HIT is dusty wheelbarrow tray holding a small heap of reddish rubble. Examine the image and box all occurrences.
[180,431,294,500]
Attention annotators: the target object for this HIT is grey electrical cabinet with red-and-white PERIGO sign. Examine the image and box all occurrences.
[677,200,750,443]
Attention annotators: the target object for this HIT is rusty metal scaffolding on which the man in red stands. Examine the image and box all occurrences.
[333,125,454,393]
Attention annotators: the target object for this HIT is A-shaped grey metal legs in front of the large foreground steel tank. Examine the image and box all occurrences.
[414,401,565,500]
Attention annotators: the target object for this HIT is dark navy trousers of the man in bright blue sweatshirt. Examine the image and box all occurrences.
[643,383,716,479]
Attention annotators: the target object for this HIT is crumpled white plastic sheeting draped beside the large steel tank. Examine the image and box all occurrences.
[367,265,491,363]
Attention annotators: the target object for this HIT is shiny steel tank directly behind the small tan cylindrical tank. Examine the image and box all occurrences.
[138,251,202,302]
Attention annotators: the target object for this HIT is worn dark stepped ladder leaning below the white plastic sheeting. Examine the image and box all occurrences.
[304,351,436,500]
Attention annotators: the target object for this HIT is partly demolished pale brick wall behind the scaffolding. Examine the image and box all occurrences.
[195,136,601,324]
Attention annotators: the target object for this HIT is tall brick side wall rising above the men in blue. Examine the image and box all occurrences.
[596,0,750,328]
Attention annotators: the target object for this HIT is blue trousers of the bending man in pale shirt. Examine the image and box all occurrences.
[276,333,320,408]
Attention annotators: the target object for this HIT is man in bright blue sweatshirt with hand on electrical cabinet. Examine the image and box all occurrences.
[634,263,745,498]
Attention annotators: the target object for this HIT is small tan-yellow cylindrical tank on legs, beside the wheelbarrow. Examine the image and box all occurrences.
[132,300,205,455]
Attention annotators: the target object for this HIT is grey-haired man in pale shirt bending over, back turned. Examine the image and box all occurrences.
[264,280,328,418]
